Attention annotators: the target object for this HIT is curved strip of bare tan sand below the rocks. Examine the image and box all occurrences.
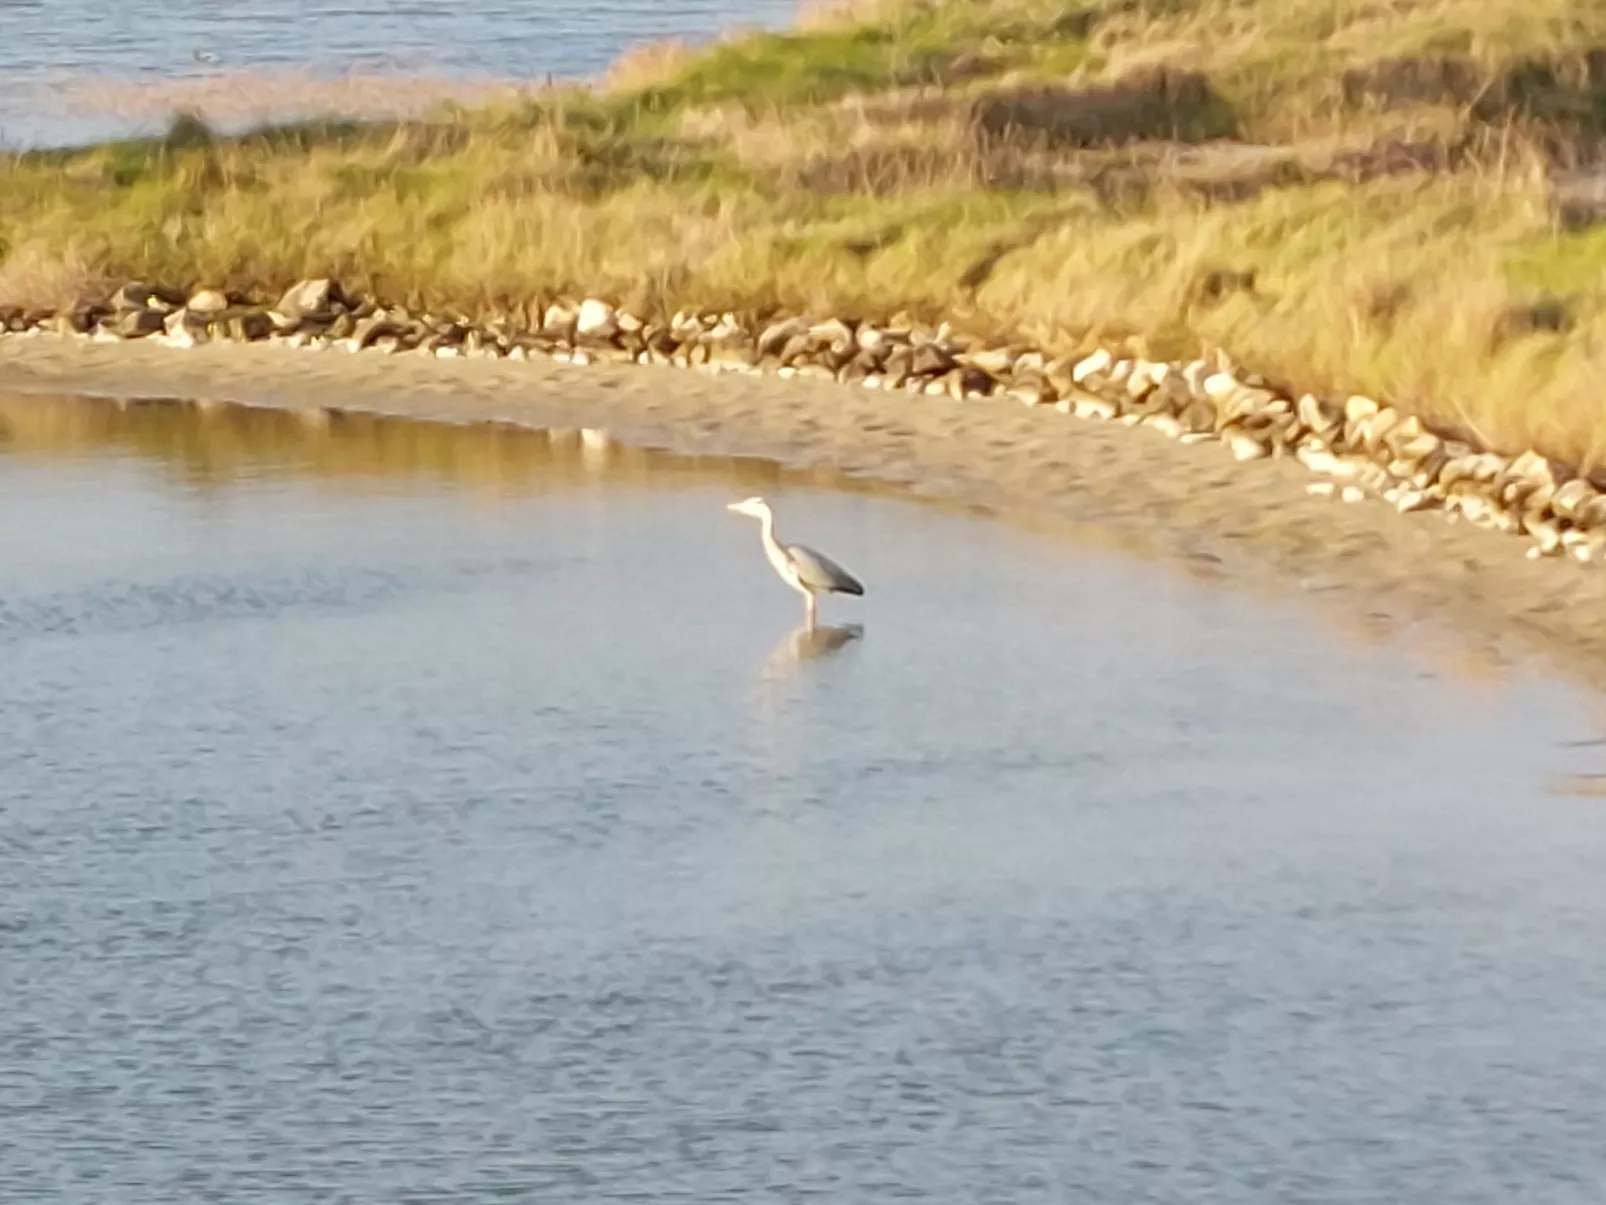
[9,337,1606,686]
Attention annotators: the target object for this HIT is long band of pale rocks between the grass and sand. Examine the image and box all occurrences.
[0,280,1606,561]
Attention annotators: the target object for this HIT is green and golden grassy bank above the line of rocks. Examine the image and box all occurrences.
[0,0,1606,468]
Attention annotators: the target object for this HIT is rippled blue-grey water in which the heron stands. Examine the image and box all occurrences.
[0,400,1606,1205]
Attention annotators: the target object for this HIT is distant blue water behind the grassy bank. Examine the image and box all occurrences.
[0,0,798,146]
